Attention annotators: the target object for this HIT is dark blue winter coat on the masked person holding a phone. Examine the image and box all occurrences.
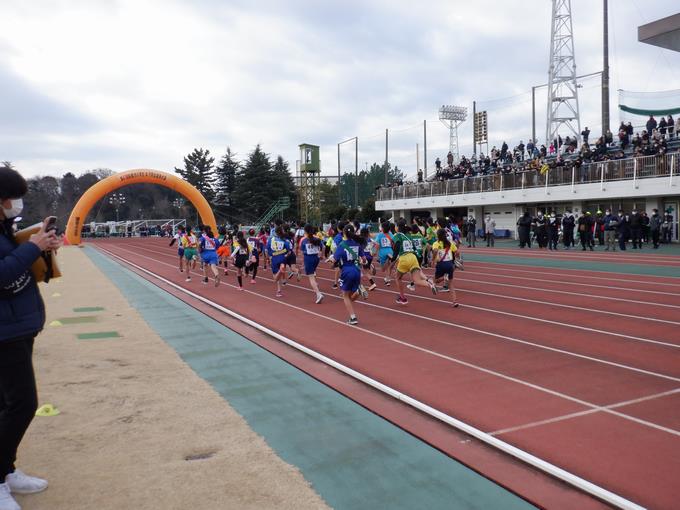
[0,225,45,342]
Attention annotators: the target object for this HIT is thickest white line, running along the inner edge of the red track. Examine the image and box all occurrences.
[94,244,644,510]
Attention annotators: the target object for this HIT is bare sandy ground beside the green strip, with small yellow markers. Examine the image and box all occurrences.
[17,247,327,510]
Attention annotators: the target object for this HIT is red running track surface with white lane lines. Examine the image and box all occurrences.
[90,239,680,508]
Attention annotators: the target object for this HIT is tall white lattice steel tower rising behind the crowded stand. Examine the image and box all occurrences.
[545,0,581,149]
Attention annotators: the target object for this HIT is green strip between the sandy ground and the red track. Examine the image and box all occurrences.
[86,248,533,510]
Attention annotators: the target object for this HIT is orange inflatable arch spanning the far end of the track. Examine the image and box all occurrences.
[66,168,217,244]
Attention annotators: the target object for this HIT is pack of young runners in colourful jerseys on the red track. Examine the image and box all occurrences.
[170,219,463,325]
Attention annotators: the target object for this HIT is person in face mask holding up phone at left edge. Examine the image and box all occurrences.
[0,166,61,510]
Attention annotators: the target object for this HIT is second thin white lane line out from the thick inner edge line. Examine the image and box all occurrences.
[120,243,680,382]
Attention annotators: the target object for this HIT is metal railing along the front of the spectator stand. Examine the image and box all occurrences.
[377,152,680,201]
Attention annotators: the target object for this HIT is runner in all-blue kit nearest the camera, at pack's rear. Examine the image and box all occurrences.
[329,225,368,326]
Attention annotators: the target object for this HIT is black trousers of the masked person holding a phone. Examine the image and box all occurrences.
[0,337,38,482]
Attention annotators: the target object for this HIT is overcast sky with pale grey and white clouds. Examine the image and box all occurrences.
[0,0,680,180]
